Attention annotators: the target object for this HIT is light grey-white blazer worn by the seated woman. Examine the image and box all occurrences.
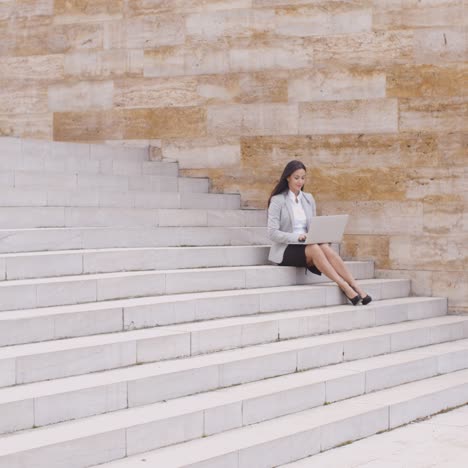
[268,190,317,263]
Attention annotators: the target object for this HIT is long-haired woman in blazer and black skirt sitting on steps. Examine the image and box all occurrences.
[268,161,372,305]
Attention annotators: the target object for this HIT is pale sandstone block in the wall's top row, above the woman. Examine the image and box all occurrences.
[275,2,372,37]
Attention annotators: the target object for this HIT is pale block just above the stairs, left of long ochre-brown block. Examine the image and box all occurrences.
[162,138,240,169]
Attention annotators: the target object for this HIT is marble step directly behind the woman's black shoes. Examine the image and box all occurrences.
[0,272,400,346]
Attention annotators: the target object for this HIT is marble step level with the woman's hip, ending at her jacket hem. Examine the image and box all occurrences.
[0,244,270,281]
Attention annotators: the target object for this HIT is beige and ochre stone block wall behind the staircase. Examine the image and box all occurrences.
[0,0,468,311]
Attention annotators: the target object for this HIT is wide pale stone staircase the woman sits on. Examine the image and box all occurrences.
[0,138,468,468]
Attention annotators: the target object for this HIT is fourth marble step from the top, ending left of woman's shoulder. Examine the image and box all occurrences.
[0,189,241,209]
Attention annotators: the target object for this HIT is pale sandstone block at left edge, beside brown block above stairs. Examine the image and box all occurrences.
[0,113,52,140]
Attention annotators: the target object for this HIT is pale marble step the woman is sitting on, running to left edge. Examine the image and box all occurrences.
[0,262,373,311]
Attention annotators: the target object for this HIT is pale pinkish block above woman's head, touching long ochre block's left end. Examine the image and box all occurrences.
[207,104,298,136]
